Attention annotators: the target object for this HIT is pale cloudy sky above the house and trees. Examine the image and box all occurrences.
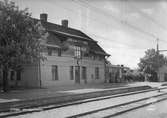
[12,0,167,68]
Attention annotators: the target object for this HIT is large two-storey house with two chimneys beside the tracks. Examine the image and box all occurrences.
[1,14,109,87]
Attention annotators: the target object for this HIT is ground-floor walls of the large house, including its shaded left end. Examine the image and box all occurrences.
[1,51,104,87]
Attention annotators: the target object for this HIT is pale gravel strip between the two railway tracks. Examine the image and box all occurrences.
[6,87,167,118]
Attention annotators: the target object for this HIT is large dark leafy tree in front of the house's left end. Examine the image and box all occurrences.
[0,0,43,92]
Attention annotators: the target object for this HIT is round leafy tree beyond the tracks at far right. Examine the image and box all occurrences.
[138,49,167,81]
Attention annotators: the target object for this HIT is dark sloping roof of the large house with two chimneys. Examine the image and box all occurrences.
[34,19,109,56]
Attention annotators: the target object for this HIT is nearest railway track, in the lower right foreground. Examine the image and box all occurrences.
[67,90,167,118]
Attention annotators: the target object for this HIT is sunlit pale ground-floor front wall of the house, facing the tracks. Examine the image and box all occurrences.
[41,56,104,86]
